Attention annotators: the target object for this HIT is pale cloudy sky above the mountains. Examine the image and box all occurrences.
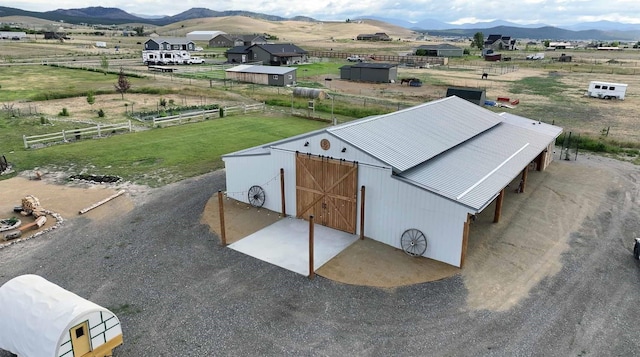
[11,0,640,25]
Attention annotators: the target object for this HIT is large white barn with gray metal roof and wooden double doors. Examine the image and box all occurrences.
[223,96,562,267]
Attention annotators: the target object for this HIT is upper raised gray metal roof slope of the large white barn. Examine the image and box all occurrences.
[327,96,502,172]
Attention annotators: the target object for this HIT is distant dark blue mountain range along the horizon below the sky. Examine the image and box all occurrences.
[0,6,640,41]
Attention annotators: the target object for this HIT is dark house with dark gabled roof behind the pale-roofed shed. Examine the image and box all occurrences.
[226,44,307,66]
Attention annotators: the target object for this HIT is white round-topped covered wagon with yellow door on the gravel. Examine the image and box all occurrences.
[0,275,122,357]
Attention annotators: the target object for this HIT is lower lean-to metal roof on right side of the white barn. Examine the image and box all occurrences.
[398,112,562,211]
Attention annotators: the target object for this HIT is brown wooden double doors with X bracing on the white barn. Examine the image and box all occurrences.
[296,154,358,234]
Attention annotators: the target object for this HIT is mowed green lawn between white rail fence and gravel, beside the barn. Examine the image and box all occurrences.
[0,116,326,187]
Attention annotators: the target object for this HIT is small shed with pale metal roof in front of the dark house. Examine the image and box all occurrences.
[225,64,297,86]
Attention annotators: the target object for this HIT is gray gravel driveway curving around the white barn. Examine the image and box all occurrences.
[0,157,640,357]
